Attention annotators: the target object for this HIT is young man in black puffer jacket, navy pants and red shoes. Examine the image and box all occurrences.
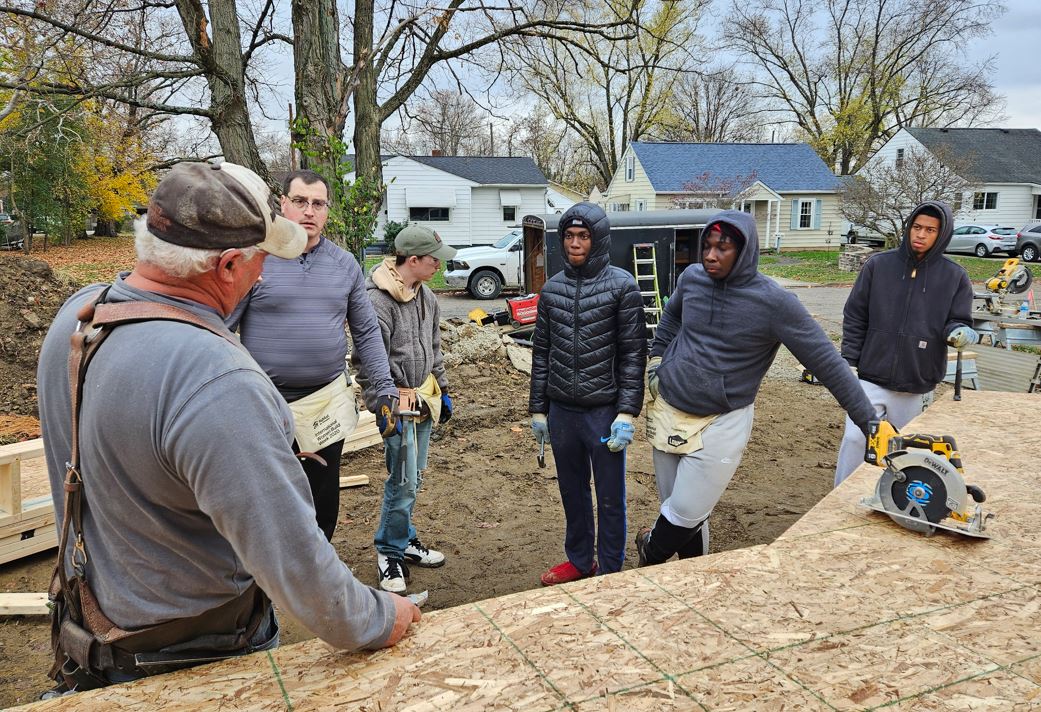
[529,203,646,586]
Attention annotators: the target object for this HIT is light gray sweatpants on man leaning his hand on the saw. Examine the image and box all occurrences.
[652,405,755,552]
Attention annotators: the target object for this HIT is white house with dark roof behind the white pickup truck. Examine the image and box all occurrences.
[348,155,549,247]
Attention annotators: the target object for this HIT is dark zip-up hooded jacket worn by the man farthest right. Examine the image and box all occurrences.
[842,202,972,393]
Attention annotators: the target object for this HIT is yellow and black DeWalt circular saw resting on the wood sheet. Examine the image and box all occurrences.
[860,421,994,539]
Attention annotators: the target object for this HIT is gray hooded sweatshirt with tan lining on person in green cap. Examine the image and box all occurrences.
[351,257,449,412]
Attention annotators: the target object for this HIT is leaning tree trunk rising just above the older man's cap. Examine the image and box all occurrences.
[177,0,269,180]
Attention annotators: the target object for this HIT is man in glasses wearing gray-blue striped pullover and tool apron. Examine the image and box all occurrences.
[229,171,398,541]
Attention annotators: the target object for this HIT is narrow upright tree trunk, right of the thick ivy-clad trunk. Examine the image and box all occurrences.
[354,0,383,183]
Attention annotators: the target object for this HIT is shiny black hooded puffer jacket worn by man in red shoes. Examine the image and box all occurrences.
[529,203,646,415]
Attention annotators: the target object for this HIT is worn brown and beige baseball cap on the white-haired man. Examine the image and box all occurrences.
[146,161,307,259]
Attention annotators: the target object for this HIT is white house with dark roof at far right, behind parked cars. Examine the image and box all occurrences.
[868,128,1041,228]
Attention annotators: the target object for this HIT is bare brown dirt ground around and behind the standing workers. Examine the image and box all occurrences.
[0,260,866,707]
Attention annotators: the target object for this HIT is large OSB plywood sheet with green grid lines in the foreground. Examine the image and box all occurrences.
[16,391,1041,711]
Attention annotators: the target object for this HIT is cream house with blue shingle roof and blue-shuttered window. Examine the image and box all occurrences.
[600,142,845,249]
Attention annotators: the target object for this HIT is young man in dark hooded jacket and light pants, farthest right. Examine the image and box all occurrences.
[835,202,980,487]
